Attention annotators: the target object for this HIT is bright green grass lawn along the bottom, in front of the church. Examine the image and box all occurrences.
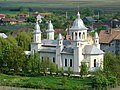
[0,74,91,89]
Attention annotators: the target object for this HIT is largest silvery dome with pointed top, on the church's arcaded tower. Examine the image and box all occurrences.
[71,12,87,30]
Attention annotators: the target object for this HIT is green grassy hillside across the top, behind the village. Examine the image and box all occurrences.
[0,0,120,13]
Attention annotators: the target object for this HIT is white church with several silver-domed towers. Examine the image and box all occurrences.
[28,12,104,72]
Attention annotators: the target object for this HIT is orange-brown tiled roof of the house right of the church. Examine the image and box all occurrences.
[99,29,120,43]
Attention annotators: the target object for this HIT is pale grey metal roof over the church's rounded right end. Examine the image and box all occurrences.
[83,45,104,55]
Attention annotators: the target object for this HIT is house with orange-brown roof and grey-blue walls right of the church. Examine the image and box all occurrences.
[99,28,120,54]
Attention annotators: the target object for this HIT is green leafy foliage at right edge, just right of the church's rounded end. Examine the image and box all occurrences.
[104,53,120,79]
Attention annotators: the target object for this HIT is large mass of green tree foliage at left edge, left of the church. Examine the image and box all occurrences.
[0,36,25,73]
